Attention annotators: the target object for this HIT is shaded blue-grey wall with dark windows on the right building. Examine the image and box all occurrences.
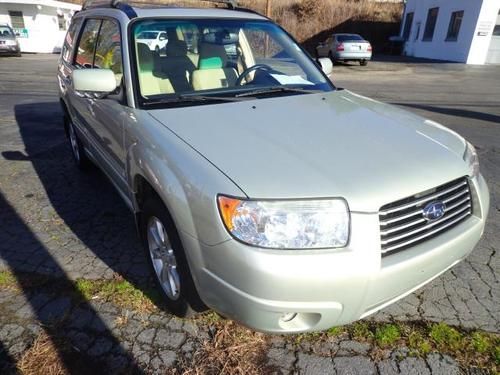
[403,0,482,62]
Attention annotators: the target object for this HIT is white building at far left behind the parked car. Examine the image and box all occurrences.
[0,0,81,53]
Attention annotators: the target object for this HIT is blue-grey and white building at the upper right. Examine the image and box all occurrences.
[401,0,500,64]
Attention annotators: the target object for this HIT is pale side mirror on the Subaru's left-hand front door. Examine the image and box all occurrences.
[72,69,116,94]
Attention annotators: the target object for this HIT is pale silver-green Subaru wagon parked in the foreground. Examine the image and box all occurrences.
[58,2,489,333]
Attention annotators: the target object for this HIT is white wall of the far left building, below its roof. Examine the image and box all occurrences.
[0,3,75,53]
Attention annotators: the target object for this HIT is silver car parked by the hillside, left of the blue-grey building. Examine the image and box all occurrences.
[316,34,372,66]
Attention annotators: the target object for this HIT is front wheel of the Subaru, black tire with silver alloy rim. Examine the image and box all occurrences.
[140,197,207,318]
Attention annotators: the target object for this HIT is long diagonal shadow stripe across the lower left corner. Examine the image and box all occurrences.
[0,193,142,374]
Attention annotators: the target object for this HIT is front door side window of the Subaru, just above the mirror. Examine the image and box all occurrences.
[94,20,123,85]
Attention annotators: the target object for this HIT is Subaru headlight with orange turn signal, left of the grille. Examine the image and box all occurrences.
[218,196,349,249]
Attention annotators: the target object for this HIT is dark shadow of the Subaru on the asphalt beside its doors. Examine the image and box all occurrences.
[6,102,157,289]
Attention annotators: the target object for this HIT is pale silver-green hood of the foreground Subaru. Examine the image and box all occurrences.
[150,90,468,212]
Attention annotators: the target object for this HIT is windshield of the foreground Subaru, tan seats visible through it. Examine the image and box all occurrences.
[132,19,334,104]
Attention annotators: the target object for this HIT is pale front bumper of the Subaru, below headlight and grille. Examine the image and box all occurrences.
[181,177,489,333]
